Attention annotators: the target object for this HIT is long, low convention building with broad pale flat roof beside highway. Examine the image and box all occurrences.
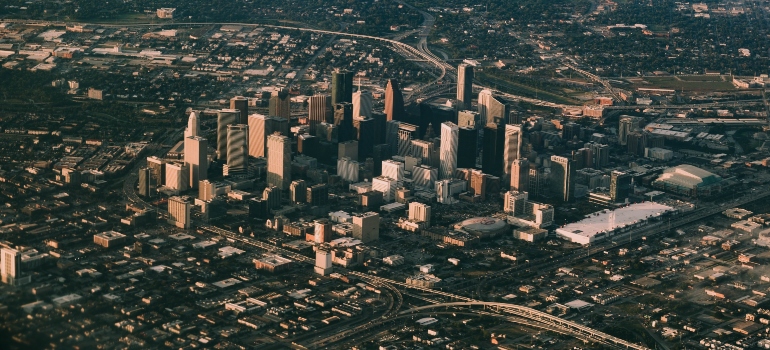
[557,202,674,241]
